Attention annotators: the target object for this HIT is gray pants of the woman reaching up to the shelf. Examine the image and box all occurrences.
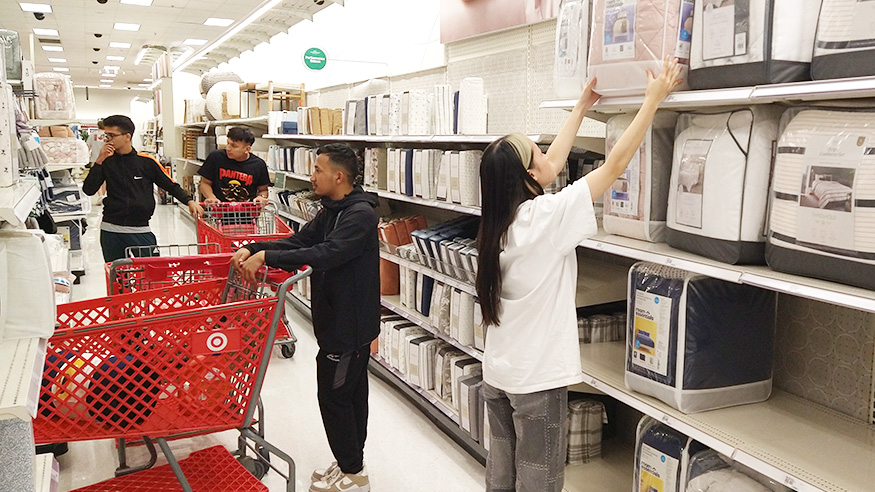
[483,383,568,492]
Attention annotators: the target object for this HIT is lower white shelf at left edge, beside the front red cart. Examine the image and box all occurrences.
[0,338,46,422]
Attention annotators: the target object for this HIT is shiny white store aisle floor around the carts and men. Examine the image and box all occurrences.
[58,205,484,492]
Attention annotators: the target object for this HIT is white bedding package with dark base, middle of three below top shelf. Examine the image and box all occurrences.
[666,105,781,264]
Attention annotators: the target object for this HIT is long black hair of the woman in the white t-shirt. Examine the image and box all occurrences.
[475,138,544,326]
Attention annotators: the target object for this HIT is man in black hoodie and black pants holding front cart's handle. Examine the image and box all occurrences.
[231,144,380,492]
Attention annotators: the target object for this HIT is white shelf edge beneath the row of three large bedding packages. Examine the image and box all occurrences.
[581,231,875,313]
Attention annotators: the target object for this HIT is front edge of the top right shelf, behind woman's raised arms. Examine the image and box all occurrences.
[540,77,875,117]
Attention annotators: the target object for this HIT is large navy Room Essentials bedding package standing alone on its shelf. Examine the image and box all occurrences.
[624,262,777,413]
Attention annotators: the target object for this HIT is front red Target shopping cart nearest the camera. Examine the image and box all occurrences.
[33,269,310,492]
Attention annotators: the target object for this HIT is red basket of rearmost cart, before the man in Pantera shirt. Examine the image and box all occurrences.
[197,202,294,253]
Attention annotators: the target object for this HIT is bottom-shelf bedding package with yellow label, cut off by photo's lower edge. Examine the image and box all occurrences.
[632,416,706,492]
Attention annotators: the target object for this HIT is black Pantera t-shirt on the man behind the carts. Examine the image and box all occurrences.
[198,150,271,202]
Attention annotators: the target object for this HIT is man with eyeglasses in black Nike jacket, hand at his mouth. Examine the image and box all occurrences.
[82,115,204,262]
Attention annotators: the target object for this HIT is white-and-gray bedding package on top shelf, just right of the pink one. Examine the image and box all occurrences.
[690,0,821,89]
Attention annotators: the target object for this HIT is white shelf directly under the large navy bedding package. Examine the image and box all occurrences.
[580,342,875,492]
